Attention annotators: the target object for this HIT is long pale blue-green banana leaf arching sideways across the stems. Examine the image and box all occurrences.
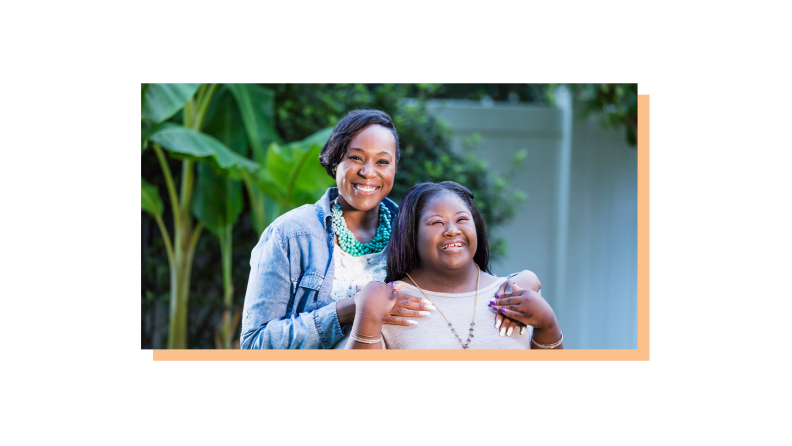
[148,122,261,178]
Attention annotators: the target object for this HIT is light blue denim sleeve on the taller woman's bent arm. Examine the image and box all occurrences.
[240,226,343,349]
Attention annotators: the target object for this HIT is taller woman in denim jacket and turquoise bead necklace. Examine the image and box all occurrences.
[240,110,434,349]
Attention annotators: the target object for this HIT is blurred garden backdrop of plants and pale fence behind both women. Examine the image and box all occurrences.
[141,84,637,349]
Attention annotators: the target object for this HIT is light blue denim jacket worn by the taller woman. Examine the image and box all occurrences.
[240,187,397,349]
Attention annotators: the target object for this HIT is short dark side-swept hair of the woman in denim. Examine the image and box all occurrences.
[319,110,401,178]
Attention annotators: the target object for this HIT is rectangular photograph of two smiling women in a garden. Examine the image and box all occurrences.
[141,83,636,352]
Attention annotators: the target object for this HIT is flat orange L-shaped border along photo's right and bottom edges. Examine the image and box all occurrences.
[154,95,649,361]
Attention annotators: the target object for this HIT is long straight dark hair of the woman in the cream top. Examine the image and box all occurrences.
[385,181,491,282]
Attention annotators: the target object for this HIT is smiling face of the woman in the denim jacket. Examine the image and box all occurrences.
[336,124,396,211]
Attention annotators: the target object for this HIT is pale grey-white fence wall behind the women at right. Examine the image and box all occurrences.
[429,98,637,348]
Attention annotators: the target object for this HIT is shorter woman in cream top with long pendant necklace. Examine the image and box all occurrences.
[346,181,564,349]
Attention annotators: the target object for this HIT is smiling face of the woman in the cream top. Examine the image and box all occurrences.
[418,192,478,270]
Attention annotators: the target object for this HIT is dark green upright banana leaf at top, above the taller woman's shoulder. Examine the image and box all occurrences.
[226,84,281,163]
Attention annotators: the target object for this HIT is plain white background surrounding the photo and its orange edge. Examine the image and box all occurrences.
[0,1,792,445]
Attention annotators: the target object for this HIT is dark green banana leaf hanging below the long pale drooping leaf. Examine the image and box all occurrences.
[192,163,243,237]
